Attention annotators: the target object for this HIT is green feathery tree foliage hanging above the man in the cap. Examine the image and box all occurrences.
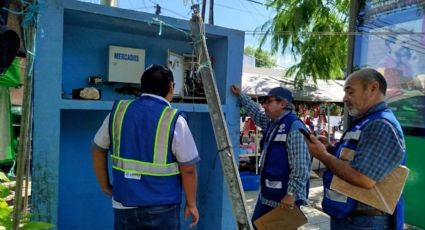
[261,0,349,88]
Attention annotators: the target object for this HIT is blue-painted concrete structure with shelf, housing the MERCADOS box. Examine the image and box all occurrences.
[31,0,244,229]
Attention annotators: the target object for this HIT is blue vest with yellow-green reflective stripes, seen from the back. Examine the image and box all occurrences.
[109,96,182,206]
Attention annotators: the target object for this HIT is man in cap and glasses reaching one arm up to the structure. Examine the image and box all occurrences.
[231,85,311,227]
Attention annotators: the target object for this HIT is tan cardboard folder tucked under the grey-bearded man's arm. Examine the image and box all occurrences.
[330,166,409,214]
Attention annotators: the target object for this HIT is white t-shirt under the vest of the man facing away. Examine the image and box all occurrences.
[94,94,200,209]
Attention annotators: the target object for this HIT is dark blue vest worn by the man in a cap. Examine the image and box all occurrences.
[260,113,301,203]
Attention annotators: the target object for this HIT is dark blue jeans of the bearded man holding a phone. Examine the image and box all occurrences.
[331,215,394,230]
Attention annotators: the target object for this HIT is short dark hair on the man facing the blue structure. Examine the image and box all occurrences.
[140,64,174,97]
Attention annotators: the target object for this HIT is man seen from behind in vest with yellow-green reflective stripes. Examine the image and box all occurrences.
[92,65,200,229]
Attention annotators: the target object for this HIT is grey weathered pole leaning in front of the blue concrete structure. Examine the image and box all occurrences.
[190,10,253,230]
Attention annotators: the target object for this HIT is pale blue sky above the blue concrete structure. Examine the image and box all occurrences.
[83,0,293,68]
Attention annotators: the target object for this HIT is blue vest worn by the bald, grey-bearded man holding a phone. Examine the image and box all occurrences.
[322,108,406,229]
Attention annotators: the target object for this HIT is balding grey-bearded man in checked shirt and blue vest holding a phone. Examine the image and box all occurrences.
[306,69,406,230]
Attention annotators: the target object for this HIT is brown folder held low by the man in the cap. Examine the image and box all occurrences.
[254,207,307,230]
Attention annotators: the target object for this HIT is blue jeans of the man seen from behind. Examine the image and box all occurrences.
[114,204,180,230]
